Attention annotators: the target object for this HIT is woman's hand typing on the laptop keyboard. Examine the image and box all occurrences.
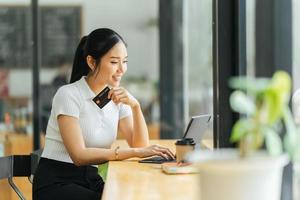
[137,144,175,159]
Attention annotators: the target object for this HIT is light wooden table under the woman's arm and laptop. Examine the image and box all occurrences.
[102,140,212,200]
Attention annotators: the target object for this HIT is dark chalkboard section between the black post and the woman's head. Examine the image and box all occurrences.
[41,7,81,67]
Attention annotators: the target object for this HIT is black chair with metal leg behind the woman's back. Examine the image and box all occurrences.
[0,149,42,200]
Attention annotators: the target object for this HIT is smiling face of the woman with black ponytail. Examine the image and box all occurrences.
[92,42,128,87]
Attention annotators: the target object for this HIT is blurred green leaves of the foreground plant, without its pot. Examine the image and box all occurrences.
[229,71,297,157]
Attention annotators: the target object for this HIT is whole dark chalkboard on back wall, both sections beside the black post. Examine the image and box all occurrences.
[0,5,81,68]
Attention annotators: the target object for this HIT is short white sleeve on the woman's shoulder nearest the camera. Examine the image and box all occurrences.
[52,87,80,118]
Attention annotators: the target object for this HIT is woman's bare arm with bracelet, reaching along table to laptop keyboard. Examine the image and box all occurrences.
[57,115,173,166]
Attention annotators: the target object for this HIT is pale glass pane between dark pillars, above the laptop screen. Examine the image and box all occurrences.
[186,0,213,116]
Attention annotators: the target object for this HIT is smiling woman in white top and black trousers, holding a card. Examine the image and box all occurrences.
[33,29,174,200]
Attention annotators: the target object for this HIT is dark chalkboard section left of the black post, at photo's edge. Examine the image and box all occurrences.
[0,6,32,67]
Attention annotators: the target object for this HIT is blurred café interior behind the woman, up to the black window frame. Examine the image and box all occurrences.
[0,0,213,199]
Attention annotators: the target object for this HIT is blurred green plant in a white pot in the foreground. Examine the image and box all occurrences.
[190,71,299,200]
